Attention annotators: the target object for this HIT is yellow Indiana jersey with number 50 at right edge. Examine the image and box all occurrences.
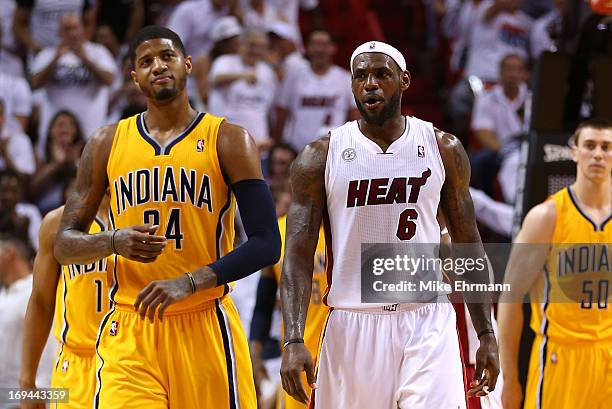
[531,187,612,343]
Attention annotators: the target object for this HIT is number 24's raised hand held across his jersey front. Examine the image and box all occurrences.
[111,224,166,263]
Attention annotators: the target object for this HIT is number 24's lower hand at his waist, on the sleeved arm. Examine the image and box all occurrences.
[134,276,191,322]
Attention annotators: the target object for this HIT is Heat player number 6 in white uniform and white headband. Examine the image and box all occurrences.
[281,41,499,409]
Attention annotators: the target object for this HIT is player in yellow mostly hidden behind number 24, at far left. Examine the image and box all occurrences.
[20,196,109,409]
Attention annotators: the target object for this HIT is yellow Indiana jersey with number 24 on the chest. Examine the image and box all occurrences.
[107,113,235,313]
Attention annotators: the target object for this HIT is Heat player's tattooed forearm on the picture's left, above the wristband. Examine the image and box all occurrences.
[281,260,313,339]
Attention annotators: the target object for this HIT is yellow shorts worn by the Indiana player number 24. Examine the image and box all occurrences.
[94,296,257,409]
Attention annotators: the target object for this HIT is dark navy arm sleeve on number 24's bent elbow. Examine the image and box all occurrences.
[209,179,281,285]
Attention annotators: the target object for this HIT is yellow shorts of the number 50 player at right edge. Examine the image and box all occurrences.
[524,336,612,409]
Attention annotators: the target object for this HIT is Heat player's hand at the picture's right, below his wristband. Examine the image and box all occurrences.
[468,334,499,397]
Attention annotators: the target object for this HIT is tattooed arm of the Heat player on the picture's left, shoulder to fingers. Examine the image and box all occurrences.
[280,137,329,403]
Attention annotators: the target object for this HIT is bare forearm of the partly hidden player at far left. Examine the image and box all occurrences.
[19,294,54,388]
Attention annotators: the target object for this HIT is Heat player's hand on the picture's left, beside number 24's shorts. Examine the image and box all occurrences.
[281,344,315,404]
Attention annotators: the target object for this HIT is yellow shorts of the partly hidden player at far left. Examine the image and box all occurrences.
[50,345,97,409]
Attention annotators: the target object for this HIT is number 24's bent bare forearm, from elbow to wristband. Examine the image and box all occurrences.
[53,228,115,265]
